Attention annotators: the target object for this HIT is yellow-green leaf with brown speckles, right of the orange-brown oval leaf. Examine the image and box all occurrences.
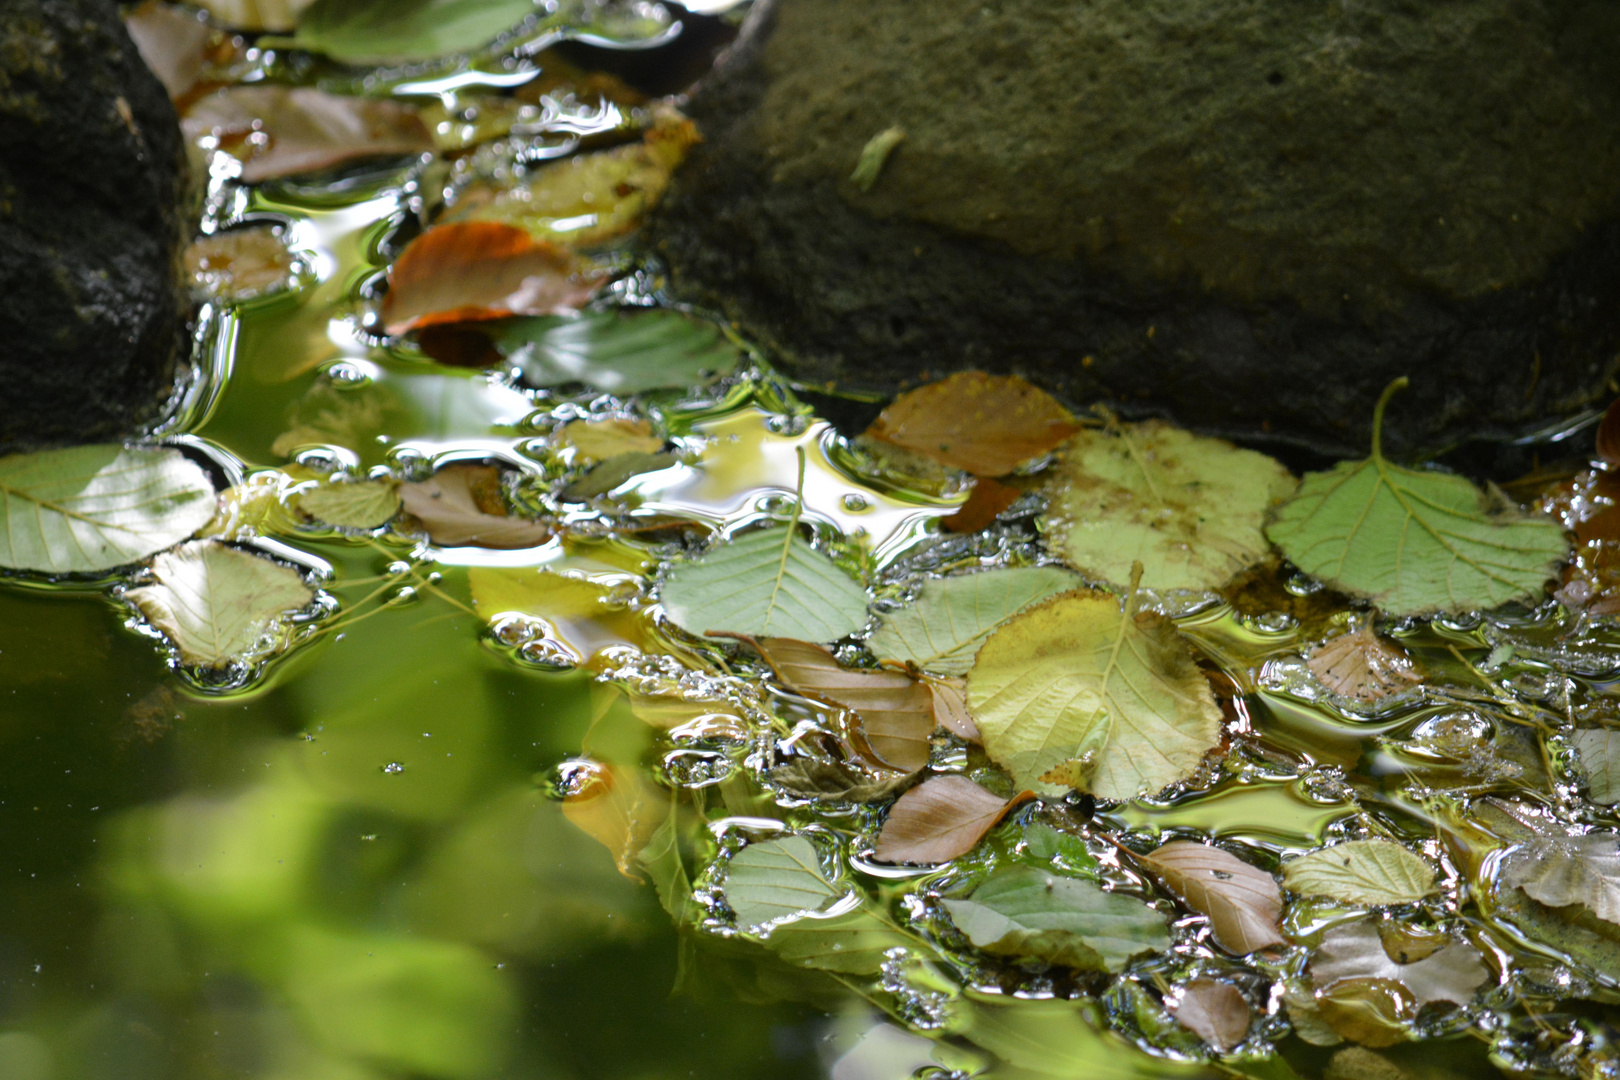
[1045,421,1294,589]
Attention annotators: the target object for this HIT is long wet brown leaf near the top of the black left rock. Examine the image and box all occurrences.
[180,86,433,183]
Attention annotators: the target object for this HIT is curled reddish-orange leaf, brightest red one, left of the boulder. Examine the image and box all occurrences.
[382,222,601,334]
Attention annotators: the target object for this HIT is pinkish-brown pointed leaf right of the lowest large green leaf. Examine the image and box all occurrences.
[1142,840,1283,955]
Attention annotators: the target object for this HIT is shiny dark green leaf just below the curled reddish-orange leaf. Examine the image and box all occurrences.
[496,311,742,393]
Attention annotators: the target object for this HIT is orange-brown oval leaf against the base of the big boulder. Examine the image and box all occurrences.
[867,371,1081,476]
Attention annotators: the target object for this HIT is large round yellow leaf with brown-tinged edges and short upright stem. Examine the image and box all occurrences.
[967,593,1221,798]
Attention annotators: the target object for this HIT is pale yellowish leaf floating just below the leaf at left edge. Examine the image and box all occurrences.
[126,541,314,667]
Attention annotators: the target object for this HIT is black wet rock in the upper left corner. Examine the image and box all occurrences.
[0,0,185,449]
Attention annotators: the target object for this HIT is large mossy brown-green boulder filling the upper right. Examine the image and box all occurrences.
[656,0,1620,455]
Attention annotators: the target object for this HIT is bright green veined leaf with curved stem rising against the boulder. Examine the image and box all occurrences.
[1267,379,1567,615]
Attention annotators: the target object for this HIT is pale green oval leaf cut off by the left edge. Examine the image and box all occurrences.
[0,445,214,573]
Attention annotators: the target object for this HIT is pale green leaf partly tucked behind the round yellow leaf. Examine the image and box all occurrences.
[870,567,1081,675]
